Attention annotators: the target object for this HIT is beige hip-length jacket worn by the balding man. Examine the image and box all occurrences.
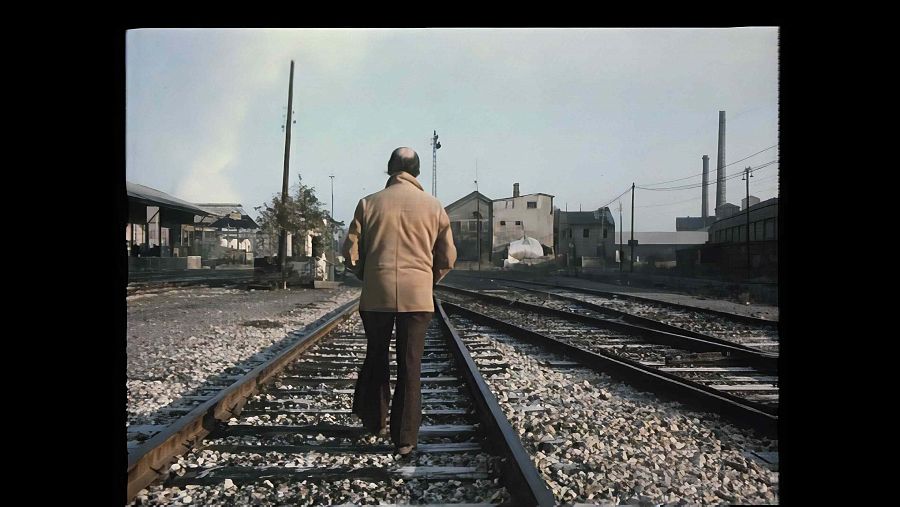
[343,172,456,312]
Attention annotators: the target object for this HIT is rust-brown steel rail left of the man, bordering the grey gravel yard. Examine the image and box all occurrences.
[125,298,359,503]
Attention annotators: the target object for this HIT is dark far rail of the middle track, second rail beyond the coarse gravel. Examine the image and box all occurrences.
[439,285,778,372]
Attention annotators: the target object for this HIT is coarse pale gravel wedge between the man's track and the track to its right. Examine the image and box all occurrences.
[451,317,778,505]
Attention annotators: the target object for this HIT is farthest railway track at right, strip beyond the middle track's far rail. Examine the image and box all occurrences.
[492,279,779,353]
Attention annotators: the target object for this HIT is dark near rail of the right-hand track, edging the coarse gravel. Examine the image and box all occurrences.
[441,301,778,436]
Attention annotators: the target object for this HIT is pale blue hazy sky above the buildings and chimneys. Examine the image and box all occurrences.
[125,27,778,231]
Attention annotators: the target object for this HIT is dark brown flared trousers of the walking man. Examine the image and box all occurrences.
[353,311,434,446]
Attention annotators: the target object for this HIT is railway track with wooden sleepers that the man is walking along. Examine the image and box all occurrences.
[128,304,555,505]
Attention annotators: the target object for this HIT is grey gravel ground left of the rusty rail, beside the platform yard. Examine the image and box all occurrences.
[126,287,359,436]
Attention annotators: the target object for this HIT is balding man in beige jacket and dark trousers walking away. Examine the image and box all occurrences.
[342,148,456,457]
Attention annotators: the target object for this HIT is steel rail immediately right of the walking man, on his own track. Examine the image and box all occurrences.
[434,297,556,506]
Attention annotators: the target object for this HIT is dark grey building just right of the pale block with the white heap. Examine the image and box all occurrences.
[554,208,616,268]
